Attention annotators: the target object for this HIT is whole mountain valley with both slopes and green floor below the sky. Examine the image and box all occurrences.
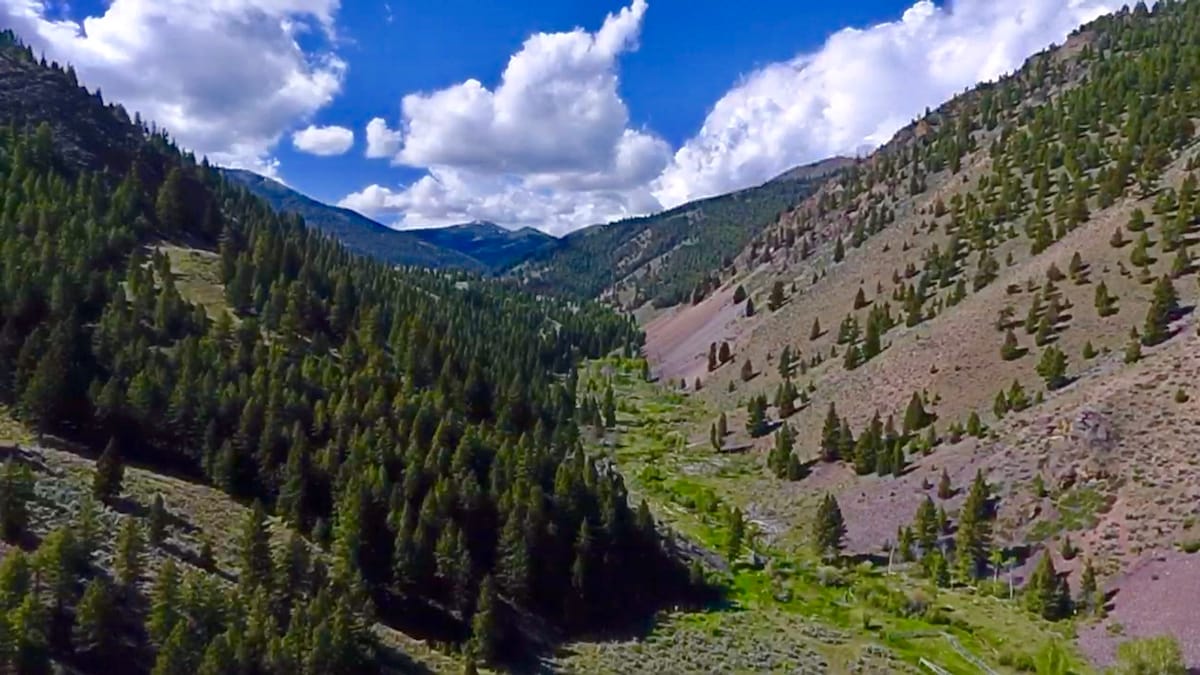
[0,0,1200,675]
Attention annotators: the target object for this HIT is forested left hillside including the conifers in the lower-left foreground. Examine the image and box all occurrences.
[0,32,688,673]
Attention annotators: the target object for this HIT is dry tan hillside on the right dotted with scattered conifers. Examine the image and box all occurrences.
[647,1,1200,667]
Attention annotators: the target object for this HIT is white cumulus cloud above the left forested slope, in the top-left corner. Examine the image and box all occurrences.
[0,0,346,174]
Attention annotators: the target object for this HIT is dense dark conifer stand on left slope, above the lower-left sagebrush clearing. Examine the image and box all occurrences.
[0,34,700,671]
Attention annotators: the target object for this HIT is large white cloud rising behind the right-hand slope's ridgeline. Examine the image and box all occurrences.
[654,0,1126,207]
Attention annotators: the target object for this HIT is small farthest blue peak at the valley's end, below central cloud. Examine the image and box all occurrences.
[407,221,558,274]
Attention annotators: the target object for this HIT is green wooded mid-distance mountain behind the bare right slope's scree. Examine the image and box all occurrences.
[510,157,853,306]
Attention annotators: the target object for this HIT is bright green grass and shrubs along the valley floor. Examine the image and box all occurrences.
[560,359,1103,673]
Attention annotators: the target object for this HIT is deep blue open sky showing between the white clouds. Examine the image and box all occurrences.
[278,0,910,202]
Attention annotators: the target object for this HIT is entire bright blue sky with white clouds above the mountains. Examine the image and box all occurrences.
[0,0,1124,234]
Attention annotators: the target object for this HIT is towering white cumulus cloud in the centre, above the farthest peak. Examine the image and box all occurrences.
[341,0,671,232]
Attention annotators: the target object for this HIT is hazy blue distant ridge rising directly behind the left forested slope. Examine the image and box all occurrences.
[222,169,487,271]
